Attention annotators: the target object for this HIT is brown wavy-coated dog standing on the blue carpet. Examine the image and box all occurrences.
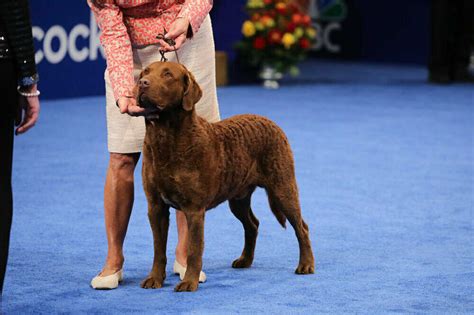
[135,62,314,291]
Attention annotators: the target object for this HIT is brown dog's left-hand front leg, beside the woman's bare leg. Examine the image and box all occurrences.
[141,198,170,289]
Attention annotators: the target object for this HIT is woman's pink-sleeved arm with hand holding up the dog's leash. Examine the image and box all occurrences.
[160,0,213,51]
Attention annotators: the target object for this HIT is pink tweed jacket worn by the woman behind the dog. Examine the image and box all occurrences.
[87,0,213,99]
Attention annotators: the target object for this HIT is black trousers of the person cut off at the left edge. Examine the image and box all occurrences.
[0,60,18,295]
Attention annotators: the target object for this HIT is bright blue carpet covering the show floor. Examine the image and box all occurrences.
[2,63,474,314]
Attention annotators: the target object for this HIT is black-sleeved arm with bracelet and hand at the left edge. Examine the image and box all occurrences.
[0,0,40,135]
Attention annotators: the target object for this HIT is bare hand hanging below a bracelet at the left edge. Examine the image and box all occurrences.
[15,84,40,135]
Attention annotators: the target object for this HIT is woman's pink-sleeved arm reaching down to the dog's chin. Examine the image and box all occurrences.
[87,0,135,107]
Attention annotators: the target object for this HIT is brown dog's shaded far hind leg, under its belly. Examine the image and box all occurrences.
[229,192,259,268]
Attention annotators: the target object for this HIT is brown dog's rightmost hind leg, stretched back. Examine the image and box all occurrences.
[265,181,314,274]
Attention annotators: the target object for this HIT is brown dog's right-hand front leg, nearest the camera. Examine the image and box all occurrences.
[175,209,206,292]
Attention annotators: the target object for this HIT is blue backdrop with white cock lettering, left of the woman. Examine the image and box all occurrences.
[30,0,105,98]
